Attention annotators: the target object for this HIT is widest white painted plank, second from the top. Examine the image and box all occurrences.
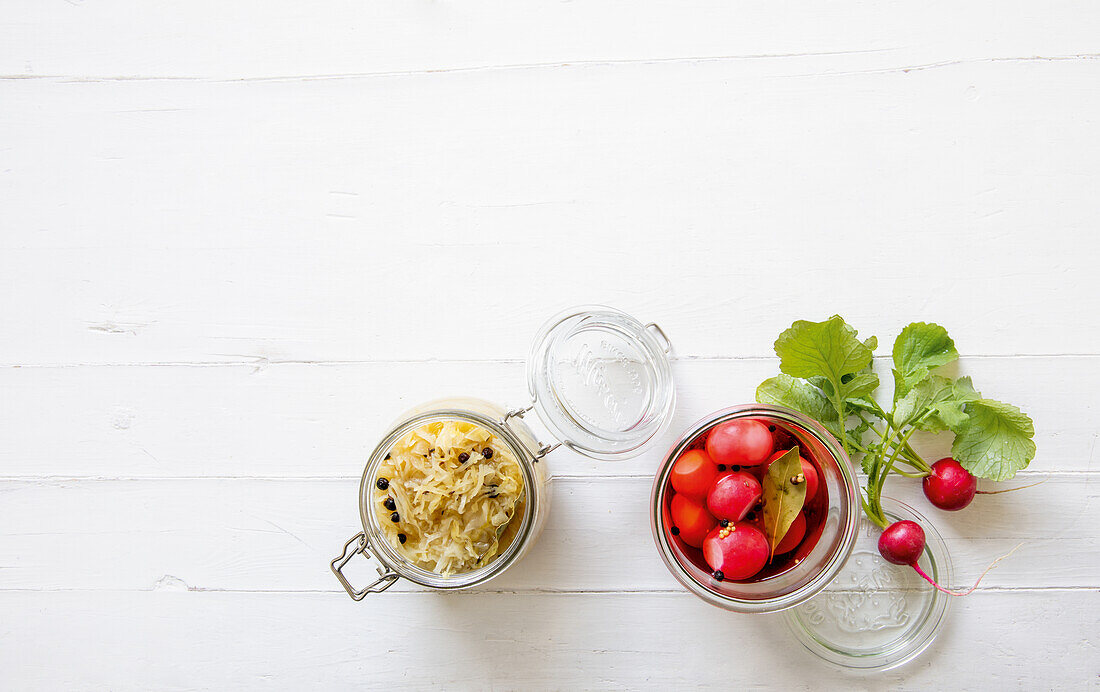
[0,58,1100,364]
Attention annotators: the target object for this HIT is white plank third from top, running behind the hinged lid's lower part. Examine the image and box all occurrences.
[0,354,1086,477]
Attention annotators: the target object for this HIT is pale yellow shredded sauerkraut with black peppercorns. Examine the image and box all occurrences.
[372,420,525,574]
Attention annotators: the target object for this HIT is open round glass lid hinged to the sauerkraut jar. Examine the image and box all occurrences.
[527,306,675,460]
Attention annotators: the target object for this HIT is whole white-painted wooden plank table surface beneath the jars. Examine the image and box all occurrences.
[0,0,1100,690]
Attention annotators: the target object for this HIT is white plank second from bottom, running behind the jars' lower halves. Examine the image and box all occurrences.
[0,474,1100,593]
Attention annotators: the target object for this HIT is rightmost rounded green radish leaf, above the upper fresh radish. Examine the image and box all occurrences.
[952,399,1035,481]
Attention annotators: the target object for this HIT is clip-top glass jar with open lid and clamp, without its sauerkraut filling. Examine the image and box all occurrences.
[330,306,675,601]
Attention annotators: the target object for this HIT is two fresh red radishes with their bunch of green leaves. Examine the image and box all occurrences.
[757,316,1035,595]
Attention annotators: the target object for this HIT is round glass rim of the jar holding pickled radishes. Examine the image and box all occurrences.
[650,404,861,613]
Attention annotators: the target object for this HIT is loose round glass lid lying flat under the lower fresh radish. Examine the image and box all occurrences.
[784,497,952,670]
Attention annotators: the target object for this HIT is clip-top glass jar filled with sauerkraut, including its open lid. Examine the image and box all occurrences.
[331,307,675,601]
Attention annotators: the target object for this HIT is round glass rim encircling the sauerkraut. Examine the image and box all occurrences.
[359,399,539,590]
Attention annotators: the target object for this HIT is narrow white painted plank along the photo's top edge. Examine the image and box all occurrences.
[0,0,1100,79]
